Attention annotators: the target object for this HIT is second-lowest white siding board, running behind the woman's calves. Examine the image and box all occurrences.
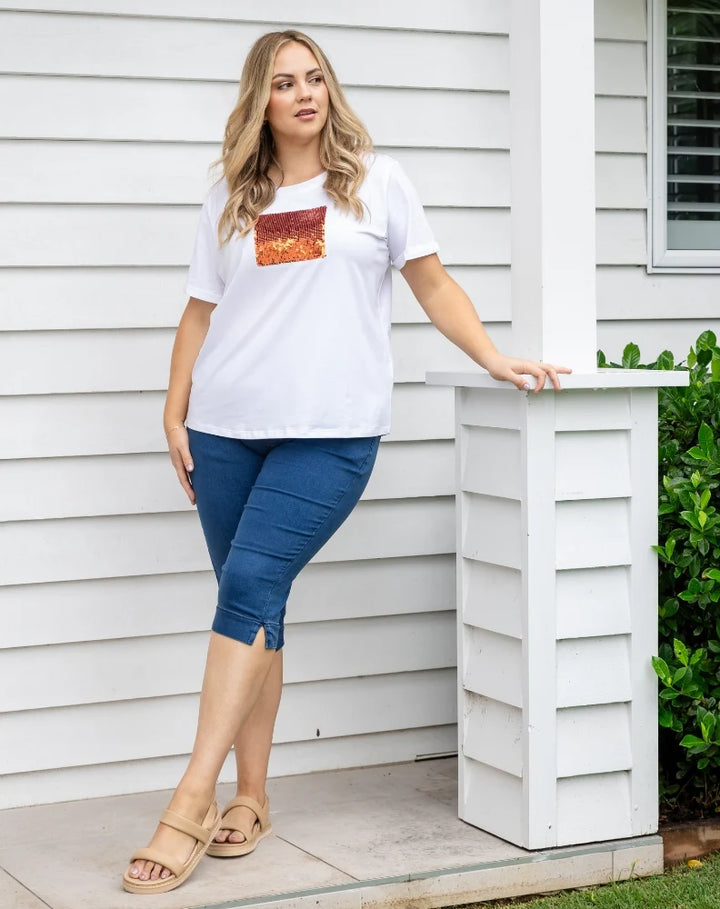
[0,669,456,774]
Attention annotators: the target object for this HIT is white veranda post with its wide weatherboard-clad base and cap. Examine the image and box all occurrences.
[428,0,685,852]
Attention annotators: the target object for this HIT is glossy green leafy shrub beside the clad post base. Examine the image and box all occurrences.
[598,331,720,814]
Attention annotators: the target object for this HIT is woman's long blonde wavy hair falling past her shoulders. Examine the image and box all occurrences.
[212,29,372,246]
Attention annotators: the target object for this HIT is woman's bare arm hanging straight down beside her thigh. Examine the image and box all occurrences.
[163,297,215,505]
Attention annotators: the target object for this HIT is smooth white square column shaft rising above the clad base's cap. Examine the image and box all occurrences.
[510,0,597,372]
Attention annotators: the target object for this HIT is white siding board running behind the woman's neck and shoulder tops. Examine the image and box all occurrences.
[0,139,646,208]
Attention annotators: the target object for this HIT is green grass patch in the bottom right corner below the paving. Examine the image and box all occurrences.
[455,853,720,909]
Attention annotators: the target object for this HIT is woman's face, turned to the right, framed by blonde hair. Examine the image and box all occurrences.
[265,41,329,144]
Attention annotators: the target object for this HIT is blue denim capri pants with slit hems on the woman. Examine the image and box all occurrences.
[188,429,380,650]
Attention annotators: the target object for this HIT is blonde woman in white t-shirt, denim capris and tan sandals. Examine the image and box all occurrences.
[123,31,568,893]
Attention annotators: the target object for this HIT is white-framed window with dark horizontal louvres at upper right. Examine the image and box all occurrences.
[651,0,720,270]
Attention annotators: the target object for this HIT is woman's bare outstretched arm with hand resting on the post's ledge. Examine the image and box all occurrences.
[401,255,572,393]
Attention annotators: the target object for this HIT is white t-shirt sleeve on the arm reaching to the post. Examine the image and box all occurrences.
[387,161,439,268]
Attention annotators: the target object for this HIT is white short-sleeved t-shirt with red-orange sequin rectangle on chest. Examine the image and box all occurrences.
[186,155,438,439]
